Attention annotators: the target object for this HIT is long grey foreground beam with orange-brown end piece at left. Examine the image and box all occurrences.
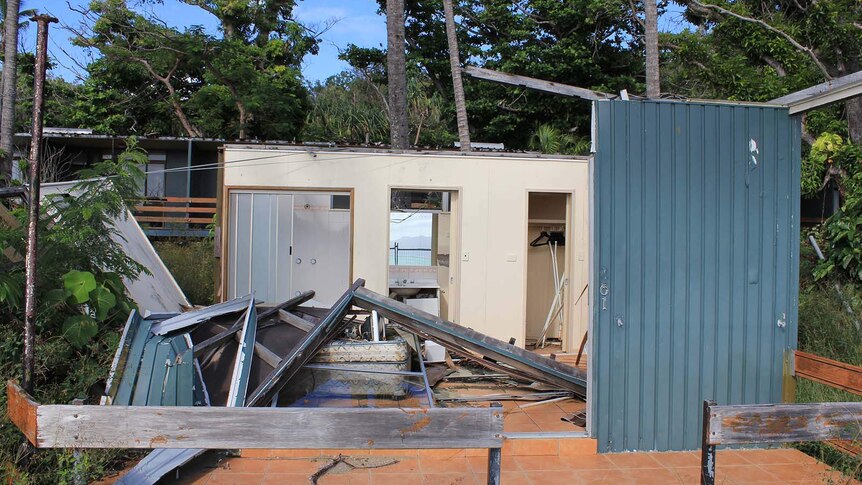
[7,382,503,449]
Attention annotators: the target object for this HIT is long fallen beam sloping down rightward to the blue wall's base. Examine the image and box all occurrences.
[353,288,587,396]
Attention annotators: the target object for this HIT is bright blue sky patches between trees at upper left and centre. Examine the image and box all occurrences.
[34,0,386,82]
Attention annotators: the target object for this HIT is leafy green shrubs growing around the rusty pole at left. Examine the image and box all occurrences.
[0,140,146,483]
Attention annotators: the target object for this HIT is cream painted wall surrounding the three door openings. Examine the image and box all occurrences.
[222,145,589,350]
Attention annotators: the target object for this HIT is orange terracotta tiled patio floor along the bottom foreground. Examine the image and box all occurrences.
[165,449,858,485]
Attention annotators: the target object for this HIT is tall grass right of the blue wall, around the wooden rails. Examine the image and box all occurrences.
[796,239,862,479]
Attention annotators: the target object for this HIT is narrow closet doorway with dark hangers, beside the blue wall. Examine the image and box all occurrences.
[525,192,571,351]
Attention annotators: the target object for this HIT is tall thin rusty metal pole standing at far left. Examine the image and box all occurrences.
[21,15,58,394]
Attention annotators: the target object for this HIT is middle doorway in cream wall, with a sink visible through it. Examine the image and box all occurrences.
[389,188,457,321]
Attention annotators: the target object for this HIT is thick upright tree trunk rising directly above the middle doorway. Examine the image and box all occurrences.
[386,0,410,150]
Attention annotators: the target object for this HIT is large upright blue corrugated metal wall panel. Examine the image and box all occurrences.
[590,101,800,451]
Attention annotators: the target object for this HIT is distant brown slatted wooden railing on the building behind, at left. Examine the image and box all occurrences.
[133,197,216,232]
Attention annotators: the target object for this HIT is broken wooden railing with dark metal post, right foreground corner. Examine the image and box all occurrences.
[701,351,862,485]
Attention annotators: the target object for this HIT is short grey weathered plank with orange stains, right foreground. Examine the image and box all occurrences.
[706,402,862,445]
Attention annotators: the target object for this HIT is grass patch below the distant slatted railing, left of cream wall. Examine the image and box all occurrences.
[153,238,216,305]
